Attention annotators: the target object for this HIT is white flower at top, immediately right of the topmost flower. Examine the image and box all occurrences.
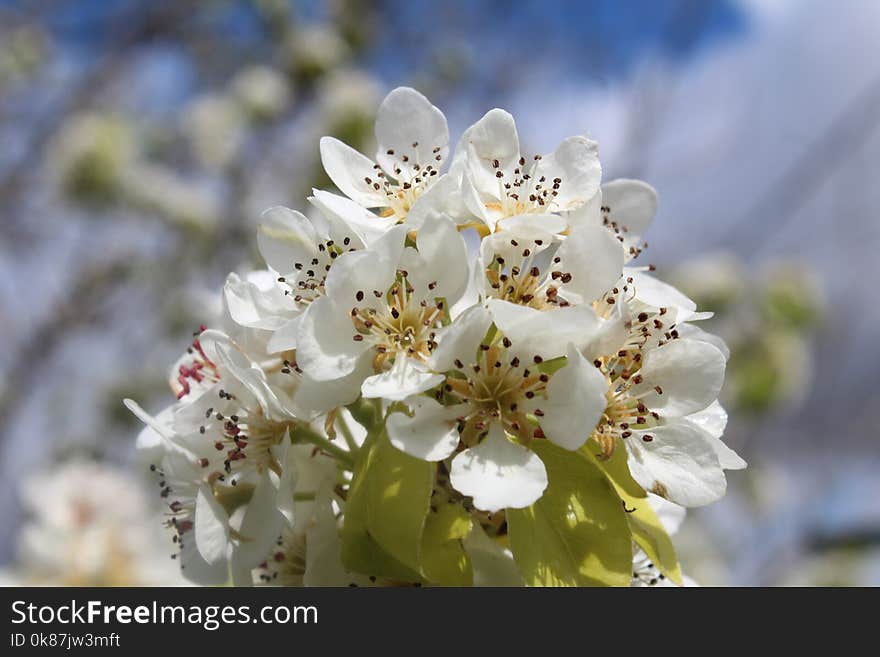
[456,109,602,232]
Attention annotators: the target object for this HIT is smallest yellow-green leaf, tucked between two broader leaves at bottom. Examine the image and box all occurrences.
[421,504,474,586]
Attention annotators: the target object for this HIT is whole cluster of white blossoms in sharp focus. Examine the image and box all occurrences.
[126,88,745,585]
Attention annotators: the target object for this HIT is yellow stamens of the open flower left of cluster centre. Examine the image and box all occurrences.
[351,270,447,372]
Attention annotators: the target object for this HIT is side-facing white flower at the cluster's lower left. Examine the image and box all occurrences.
[126,331,306,583]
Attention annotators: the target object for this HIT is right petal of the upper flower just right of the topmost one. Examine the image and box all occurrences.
[533,137,602,211]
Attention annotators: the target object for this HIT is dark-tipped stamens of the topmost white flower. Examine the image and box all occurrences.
[364,142,443,220]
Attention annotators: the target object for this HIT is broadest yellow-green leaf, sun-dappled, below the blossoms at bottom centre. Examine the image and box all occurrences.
[507,440,632,586]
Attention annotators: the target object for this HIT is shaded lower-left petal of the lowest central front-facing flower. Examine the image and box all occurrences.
[386,397,461,461]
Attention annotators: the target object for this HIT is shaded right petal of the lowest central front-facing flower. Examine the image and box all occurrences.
[533,344,608,450]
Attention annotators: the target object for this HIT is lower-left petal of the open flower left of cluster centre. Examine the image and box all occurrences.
[296,296,370,381]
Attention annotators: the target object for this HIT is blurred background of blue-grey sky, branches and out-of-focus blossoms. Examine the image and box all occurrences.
[0,0,880,585]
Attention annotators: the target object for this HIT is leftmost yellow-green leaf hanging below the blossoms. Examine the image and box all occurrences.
[342,431,434,581]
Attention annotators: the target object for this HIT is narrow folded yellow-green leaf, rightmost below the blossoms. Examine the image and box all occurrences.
[596,441,682,586]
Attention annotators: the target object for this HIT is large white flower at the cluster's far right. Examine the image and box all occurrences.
[588,276,745,506]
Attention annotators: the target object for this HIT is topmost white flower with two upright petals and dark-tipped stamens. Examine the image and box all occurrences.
[321,87,449,220]
